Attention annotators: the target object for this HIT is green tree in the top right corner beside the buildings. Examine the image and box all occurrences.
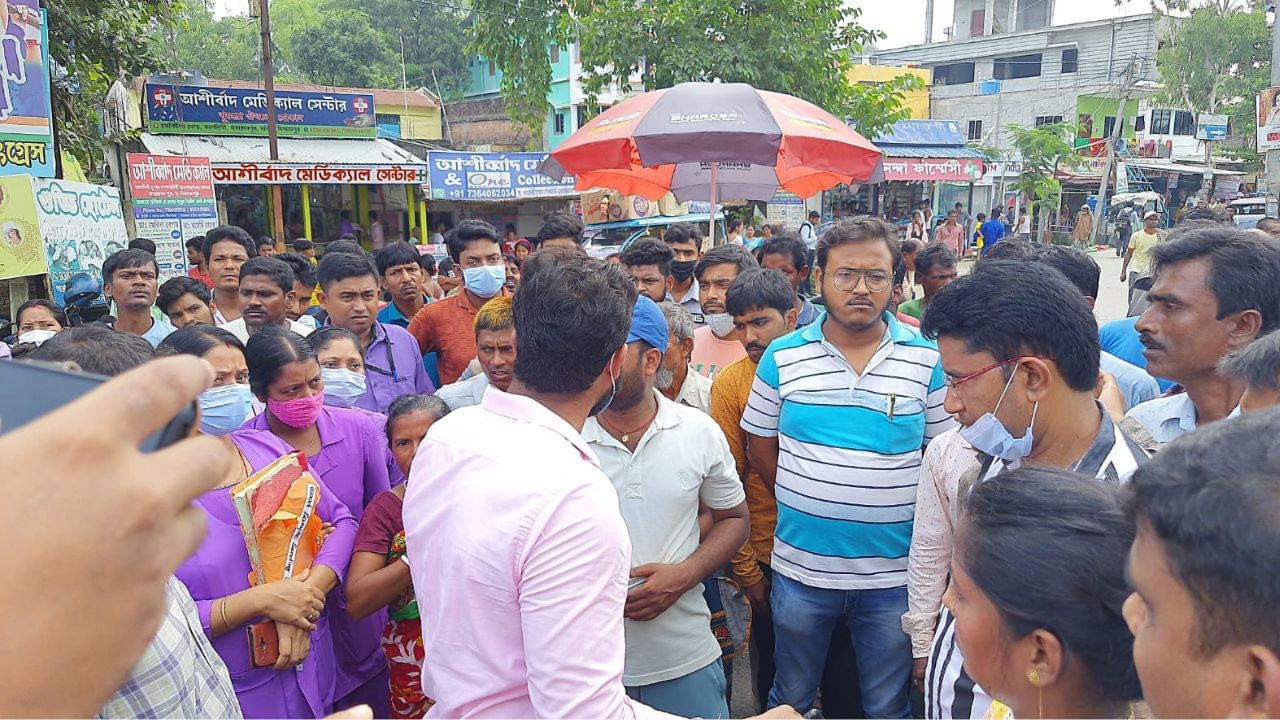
[1156,0,1271,158]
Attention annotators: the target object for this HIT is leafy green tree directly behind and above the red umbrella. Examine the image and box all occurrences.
[471,0,922,136]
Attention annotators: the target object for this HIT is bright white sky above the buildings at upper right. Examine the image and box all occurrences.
[849,0,1151,50]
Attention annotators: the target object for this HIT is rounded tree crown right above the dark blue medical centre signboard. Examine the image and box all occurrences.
[285,9,399,87]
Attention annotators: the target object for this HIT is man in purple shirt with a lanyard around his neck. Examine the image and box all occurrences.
[319,252,435,413]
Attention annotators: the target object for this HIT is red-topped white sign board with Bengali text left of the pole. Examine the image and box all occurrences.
[129,152,218,282]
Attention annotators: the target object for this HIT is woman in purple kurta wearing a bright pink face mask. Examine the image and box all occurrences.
[244,327,390,717]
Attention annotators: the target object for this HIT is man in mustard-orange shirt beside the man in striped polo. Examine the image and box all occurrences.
[712,269,799,703]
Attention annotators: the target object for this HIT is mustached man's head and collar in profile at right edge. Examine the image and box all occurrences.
[1129,224,1280,443]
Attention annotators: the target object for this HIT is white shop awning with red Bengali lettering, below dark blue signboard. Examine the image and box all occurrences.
[142,133,426,184]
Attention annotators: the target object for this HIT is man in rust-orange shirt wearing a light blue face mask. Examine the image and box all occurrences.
[408,220,508,384]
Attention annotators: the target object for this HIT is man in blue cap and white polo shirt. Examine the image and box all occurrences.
[582,295,749,717]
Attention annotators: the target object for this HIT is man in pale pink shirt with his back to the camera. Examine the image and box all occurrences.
[404,255,721,717]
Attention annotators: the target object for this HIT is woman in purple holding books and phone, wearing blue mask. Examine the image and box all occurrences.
[164,325,357,717]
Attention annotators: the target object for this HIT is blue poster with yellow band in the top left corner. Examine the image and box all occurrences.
[0,0,55,178]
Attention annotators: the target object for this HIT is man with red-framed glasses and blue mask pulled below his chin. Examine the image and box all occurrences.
[902,260,1147,717]
